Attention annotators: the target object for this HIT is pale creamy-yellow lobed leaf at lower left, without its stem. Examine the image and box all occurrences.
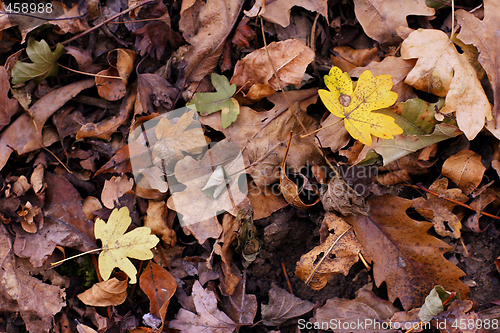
[94,207,160,284]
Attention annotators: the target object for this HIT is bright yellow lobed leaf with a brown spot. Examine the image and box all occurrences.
[318,67,403,146]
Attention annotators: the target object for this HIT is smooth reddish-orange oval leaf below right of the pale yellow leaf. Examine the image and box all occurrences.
[139,261,177,331]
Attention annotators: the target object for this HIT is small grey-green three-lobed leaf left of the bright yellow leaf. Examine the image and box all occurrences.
[188,73,240,128]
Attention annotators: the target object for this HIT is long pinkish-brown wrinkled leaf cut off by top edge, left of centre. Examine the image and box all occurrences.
[179,0,244,82]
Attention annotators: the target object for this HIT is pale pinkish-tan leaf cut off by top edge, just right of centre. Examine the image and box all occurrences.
[256,0,328,28]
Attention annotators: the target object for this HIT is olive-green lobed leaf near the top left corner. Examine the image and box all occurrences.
[12,37,64,84]
